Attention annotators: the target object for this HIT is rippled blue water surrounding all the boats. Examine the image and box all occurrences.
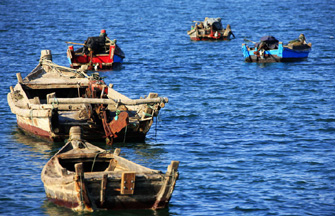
[0,0,335,215]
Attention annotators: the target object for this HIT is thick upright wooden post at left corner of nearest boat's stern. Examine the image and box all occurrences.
[74,163,93,211]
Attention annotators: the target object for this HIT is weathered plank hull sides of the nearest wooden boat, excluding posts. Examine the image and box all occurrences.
[44,176,169,210]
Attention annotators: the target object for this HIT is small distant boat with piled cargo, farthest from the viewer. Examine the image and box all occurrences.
[187,17,235,41]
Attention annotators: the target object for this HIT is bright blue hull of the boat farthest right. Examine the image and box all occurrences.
[242,42,311,63]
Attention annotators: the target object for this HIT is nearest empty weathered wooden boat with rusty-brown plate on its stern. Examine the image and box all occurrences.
[41,127,179,211]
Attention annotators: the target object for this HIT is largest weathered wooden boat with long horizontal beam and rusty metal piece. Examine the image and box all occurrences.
[7,50,168,142]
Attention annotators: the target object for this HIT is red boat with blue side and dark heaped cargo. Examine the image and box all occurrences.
[67,30,125,70]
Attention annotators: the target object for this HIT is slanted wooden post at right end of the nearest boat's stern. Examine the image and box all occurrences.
[152,161,179,209]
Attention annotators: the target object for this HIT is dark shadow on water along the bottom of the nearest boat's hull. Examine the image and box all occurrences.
[41,200,173,216]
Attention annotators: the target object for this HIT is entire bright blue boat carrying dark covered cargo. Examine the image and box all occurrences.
[242,36,312,63]
